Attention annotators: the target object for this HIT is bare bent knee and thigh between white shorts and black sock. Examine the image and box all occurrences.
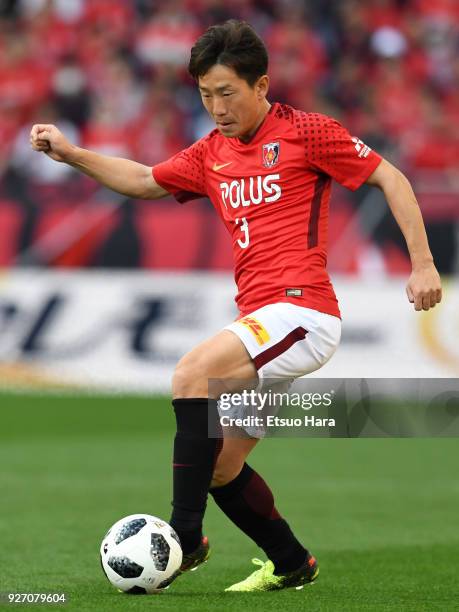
[172,330,258,399]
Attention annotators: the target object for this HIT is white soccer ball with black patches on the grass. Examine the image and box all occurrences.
[100,514,182,594]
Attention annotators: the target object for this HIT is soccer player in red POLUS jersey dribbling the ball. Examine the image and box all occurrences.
[31,20,441,591]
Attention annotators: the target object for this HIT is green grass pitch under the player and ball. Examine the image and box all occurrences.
[0,394,459,612]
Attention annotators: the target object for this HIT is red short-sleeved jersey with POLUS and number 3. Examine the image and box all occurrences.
[152,104,381,317]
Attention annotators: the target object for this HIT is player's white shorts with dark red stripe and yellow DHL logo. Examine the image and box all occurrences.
[225,302,341,380]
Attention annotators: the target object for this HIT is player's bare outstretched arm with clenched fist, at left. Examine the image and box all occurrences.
[30,124,169,200]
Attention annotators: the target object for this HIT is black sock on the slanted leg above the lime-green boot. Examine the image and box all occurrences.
[210,463,308,574]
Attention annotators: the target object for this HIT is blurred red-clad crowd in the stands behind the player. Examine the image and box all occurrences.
[0,0,459,276]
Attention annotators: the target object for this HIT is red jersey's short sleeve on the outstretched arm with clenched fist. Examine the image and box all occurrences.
[152,138,207,202]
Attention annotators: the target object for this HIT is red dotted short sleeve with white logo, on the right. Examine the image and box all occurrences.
[303,113,382,191]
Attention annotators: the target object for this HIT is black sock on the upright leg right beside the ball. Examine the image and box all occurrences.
[170,398,222,555]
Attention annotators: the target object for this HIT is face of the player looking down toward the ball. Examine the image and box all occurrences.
[198,64,270,139]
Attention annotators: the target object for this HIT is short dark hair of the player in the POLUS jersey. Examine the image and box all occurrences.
[188,19,268,86]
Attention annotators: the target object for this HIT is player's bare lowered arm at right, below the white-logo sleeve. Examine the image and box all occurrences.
[366,159,442,310]
